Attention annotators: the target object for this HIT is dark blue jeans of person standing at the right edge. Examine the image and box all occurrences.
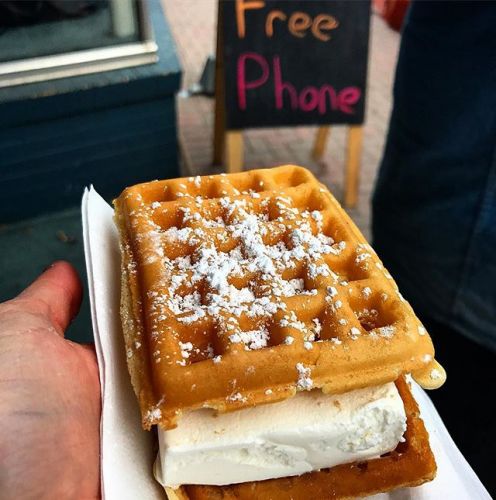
[372,1,496,351]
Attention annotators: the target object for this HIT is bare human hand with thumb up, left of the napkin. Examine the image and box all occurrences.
[0,262,100,500]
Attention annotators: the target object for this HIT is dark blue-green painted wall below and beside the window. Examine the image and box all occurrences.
[0,0,181,223]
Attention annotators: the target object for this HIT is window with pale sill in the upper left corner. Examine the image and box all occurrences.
[0,0,157,87]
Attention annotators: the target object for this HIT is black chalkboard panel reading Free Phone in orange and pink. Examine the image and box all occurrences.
[223,0,370,130]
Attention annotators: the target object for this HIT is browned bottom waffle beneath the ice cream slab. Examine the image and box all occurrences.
[167,378,437,500]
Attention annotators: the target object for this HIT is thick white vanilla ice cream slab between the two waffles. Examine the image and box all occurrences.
[155,383,406,487]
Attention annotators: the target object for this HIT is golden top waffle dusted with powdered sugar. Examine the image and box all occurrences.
[115,166,445,428]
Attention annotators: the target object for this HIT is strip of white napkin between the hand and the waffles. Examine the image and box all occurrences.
[81,187,165,500]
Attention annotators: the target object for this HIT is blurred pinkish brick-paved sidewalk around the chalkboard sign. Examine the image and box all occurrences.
[162,0,399,237]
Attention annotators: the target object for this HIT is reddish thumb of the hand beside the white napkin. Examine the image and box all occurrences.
[14,261,82,335]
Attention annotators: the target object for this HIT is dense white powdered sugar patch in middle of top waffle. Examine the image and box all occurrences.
[151,197,344,332]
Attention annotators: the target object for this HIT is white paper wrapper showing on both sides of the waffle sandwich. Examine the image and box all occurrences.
[82,188,491,500]
